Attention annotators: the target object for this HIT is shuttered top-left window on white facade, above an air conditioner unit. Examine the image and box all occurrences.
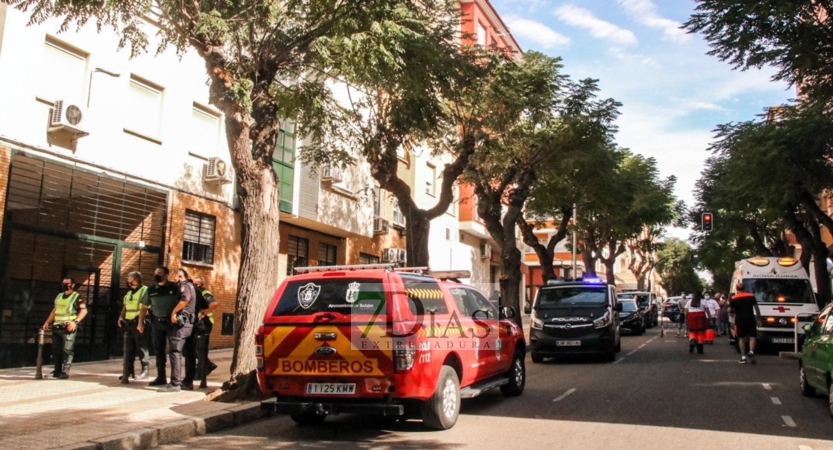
[38,36,89,105]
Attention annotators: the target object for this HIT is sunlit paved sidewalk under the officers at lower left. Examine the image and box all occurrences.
[0,349,262,450]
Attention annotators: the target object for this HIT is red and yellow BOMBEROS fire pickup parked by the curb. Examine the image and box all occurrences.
[255,265,526,430]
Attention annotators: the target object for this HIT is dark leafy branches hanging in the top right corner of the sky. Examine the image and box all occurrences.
[684,0,833,103]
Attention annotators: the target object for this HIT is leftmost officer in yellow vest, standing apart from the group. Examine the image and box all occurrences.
[43,277,87,380]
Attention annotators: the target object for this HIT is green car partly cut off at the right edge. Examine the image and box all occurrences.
[798,304,833,417]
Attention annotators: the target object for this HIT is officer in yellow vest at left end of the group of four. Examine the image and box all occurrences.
[118,272,150,384]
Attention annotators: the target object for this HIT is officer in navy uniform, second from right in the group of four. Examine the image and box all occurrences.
[154,268,197,392]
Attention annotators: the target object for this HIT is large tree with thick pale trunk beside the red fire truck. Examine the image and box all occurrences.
[11,0,458,393]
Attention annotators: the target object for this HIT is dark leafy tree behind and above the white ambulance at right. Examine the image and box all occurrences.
[703,106,833,303]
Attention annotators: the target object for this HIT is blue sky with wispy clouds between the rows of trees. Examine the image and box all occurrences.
[491,0,795,237]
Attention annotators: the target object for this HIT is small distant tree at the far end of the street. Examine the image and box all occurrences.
[656,238,703,295]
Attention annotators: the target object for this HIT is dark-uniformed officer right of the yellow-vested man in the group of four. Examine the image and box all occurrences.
[137,266,179,386]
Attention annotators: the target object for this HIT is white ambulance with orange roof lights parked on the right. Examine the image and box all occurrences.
[730,257,819,345]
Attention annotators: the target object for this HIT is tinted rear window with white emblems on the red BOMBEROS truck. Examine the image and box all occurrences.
[272,278,385,317]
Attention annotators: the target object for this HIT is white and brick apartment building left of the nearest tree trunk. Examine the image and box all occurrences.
[0,4,240,367]
